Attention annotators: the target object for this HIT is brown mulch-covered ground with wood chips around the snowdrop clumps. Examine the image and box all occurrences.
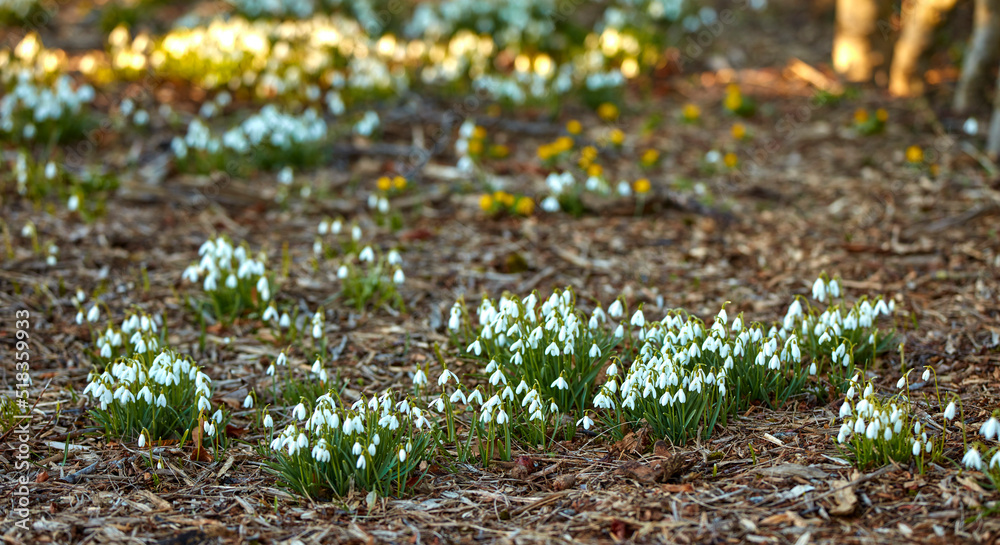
[0,0,1000,545]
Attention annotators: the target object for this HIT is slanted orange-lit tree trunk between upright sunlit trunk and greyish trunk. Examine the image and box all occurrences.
[889,0,955,96]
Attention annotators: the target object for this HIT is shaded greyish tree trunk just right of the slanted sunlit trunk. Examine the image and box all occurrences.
[954,0,1000,114]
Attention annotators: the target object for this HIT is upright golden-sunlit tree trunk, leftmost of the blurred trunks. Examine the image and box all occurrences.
[833,0,889,81]
